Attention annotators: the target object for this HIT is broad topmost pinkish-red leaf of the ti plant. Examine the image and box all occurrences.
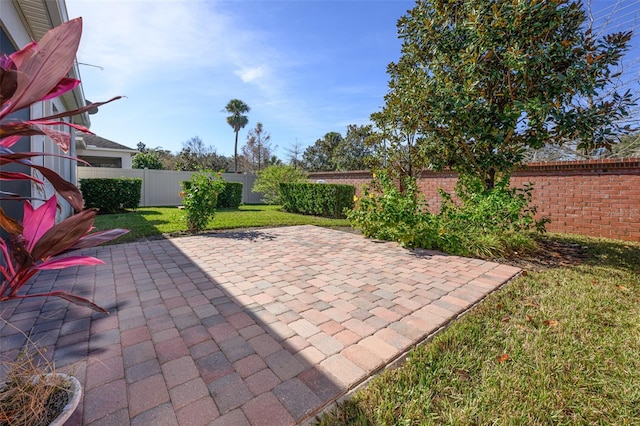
[0,18,82,118]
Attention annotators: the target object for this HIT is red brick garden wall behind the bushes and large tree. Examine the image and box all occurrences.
[310,158,640,241]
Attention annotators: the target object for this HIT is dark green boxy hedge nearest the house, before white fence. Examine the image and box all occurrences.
[79,178,142,213]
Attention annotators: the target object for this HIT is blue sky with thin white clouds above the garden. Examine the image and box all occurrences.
[66,0,640,159]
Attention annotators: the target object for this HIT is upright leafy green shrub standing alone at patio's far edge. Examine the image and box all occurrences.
[182,170,225,232]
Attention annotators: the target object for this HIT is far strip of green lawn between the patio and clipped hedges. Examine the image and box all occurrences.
[95,205,349,244]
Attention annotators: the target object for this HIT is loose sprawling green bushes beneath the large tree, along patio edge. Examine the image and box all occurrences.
[347,174,548,258]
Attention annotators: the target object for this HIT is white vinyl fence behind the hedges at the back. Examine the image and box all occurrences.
[78,167,262,207]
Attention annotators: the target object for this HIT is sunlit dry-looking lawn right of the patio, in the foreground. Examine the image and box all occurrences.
[318,237,640,426]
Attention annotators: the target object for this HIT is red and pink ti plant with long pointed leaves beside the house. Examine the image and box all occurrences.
[0,18,128,312]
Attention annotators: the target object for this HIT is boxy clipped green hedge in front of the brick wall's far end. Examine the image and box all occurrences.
[280,183,356,218]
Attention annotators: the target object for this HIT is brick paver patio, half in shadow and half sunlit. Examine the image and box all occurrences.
[0,226,519,426]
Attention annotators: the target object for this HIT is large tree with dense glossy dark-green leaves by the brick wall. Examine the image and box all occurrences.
[372,0,632,189]
